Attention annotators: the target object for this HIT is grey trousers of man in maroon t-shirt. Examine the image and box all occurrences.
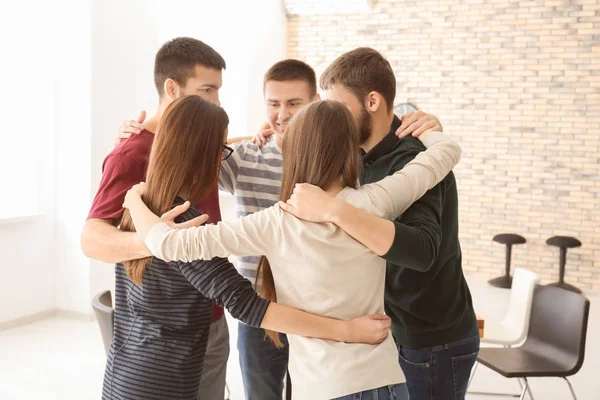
[198,316,229,400]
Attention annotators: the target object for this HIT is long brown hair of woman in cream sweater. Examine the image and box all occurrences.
[257,100,359,347]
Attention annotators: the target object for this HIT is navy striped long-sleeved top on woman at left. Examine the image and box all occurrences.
[102,202,269,400]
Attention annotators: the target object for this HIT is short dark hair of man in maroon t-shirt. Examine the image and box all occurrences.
[154,37,226,98]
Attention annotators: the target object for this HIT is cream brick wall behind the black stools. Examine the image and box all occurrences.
[288,0,600,290]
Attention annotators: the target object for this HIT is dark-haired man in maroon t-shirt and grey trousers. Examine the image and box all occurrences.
[81,38,229,400]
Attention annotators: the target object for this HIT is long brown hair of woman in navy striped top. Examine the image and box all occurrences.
[120,96,229,285]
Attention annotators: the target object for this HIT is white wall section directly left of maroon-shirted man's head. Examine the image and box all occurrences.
[85,0,160,300]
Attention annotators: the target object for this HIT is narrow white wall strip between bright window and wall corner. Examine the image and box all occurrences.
[54,0,92,314]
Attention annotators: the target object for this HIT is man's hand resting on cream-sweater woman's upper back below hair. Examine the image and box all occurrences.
[278,183,343,222]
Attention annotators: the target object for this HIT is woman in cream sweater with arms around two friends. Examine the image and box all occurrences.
[125,101,460,400]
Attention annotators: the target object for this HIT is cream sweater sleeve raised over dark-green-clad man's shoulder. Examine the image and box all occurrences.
[347,132,461,220]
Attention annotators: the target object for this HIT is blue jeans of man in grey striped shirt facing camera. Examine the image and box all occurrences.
[238,322,289,400]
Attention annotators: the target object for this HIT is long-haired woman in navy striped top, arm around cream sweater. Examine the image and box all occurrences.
[102,96,390,400]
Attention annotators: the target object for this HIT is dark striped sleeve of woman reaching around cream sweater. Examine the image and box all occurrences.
[175,258,270,328]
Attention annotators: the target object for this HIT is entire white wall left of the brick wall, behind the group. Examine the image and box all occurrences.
[0,0,287,326]
